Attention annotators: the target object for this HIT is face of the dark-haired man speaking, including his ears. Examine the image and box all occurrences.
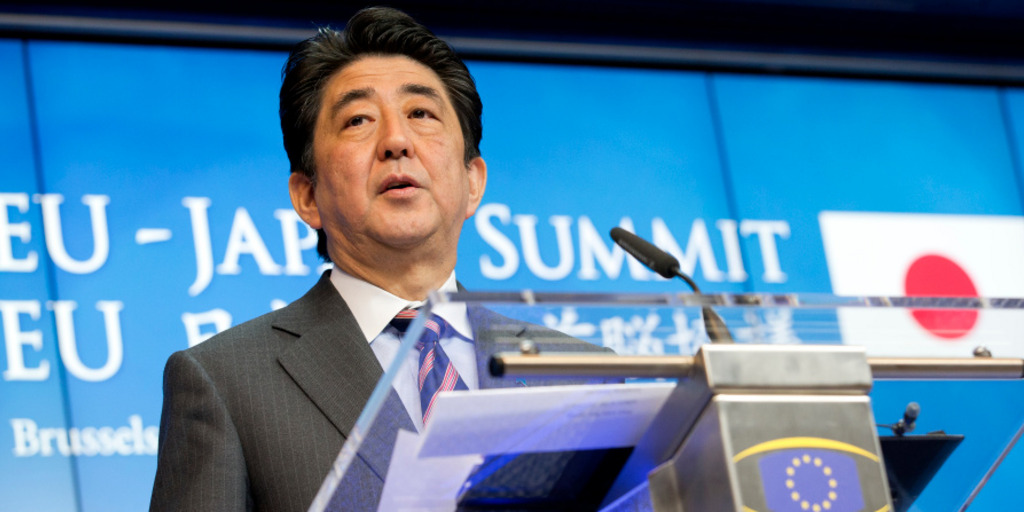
[290,56,486,269]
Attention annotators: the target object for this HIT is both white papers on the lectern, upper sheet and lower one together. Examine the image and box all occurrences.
[377,383,675,512]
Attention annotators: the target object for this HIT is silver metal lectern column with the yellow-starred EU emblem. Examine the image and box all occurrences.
[630,344,891,512]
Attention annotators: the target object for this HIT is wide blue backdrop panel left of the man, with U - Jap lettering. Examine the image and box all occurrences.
[29,42,318,511]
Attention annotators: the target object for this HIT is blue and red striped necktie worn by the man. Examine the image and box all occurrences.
[391,309,469,426]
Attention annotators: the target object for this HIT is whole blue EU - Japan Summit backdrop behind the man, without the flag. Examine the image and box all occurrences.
[0,40,1024,511]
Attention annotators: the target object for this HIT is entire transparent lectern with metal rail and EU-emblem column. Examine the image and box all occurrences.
[310,292,1024,512]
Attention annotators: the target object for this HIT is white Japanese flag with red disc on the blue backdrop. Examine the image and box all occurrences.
[818,212,1024,357]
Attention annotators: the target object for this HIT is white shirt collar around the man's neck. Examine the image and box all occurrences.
[331,267,473,341]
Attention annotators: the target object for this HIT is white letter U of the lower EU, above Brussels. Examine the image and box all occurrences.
[47,300,124,382]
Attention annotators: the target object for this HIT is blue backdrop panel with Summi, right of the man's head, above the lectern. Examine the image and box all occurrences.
[457,62,746,291]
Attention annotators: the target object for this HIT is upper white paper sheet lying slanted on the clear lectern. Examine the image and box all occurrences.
[419,382,675,458]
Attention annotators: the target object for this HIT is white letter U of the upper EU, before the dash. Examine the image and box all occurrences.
[35,194,111,273]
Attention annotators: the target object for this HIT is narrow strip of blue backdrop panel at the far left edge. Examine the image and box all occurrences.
[0,40,77,510]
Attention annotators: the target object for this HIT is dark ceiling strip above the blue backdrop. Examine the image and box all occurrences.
[6,0,1024,82]
